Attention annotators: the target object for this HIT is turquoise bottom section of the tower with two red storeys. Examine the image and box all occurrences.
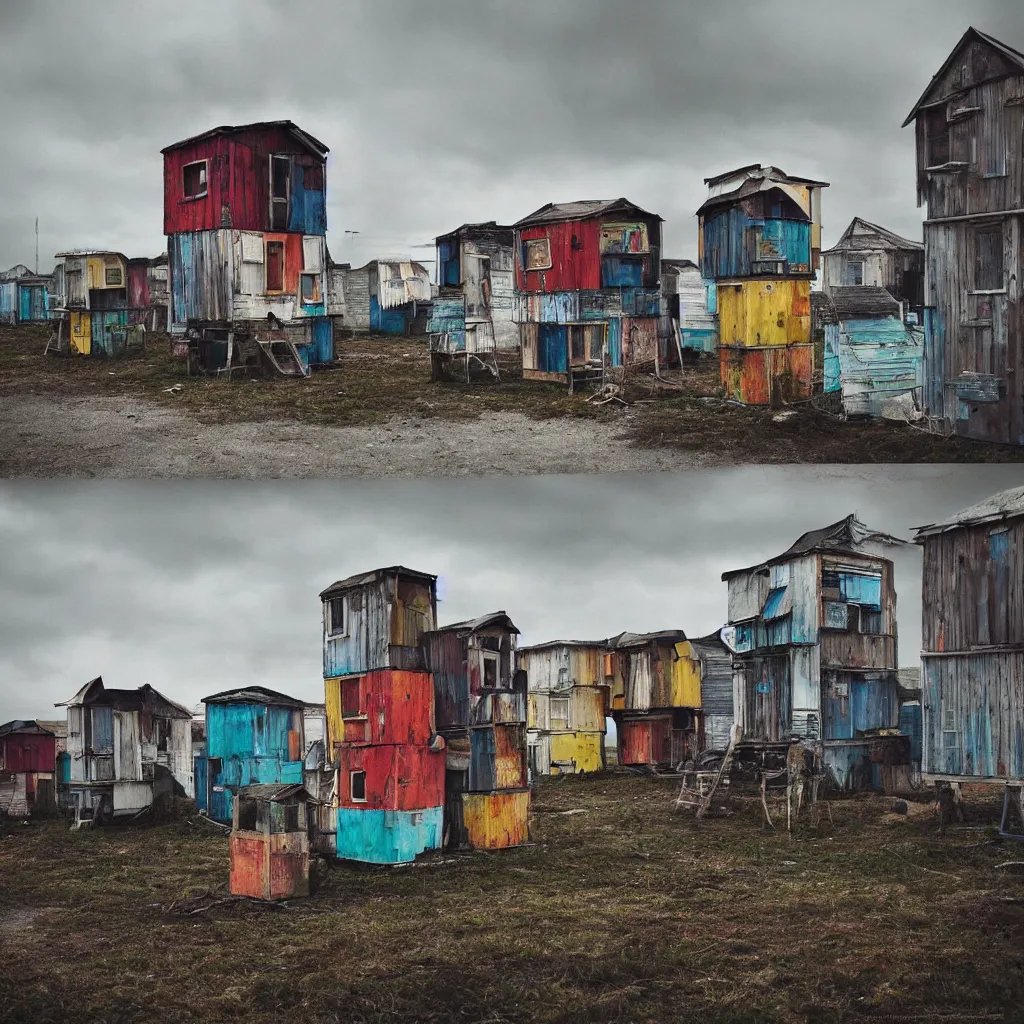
[337,807,444,864]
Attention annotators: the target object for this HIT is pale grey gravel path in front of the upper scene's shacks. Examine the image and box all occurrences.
[0,395,712,478]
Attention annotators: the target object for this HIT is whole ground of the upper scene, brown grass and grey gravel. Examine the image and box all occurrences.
[0,327,1024,478]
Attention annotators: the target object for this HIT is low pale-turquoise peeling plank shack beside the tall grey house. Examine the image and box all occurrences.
[824,285,925,422]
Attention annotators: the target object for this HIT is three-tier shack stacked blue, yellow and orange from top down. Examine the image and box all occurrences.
[697,164,828,406]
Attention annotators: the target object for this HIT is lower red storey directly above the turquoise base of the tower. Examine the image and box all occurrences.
[338,743,445,811]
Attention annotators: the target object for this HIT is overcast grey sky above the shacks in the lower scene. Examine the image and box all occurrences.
[0,466,1024,722]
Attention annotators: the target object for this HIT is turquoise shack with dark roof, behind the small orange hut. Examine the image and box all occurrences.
[196,686,306,824]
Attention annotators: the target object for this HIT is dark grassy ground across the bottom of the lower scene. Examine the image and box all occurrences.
[0,773,1024,1024]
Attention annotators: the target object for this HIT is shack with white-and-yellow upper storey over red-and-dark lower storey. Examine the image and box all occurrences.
[608,630,705,766]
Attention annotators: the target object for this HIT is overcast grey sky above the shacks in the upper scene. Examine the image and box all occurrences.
[0,0,1024,269]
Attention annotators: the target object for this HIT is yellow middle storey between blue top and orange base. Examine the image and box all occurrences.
[718,280,811,348]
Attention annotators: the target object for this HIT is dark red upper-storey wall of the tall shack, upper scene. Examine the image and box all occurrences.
[164,128,325,234]
